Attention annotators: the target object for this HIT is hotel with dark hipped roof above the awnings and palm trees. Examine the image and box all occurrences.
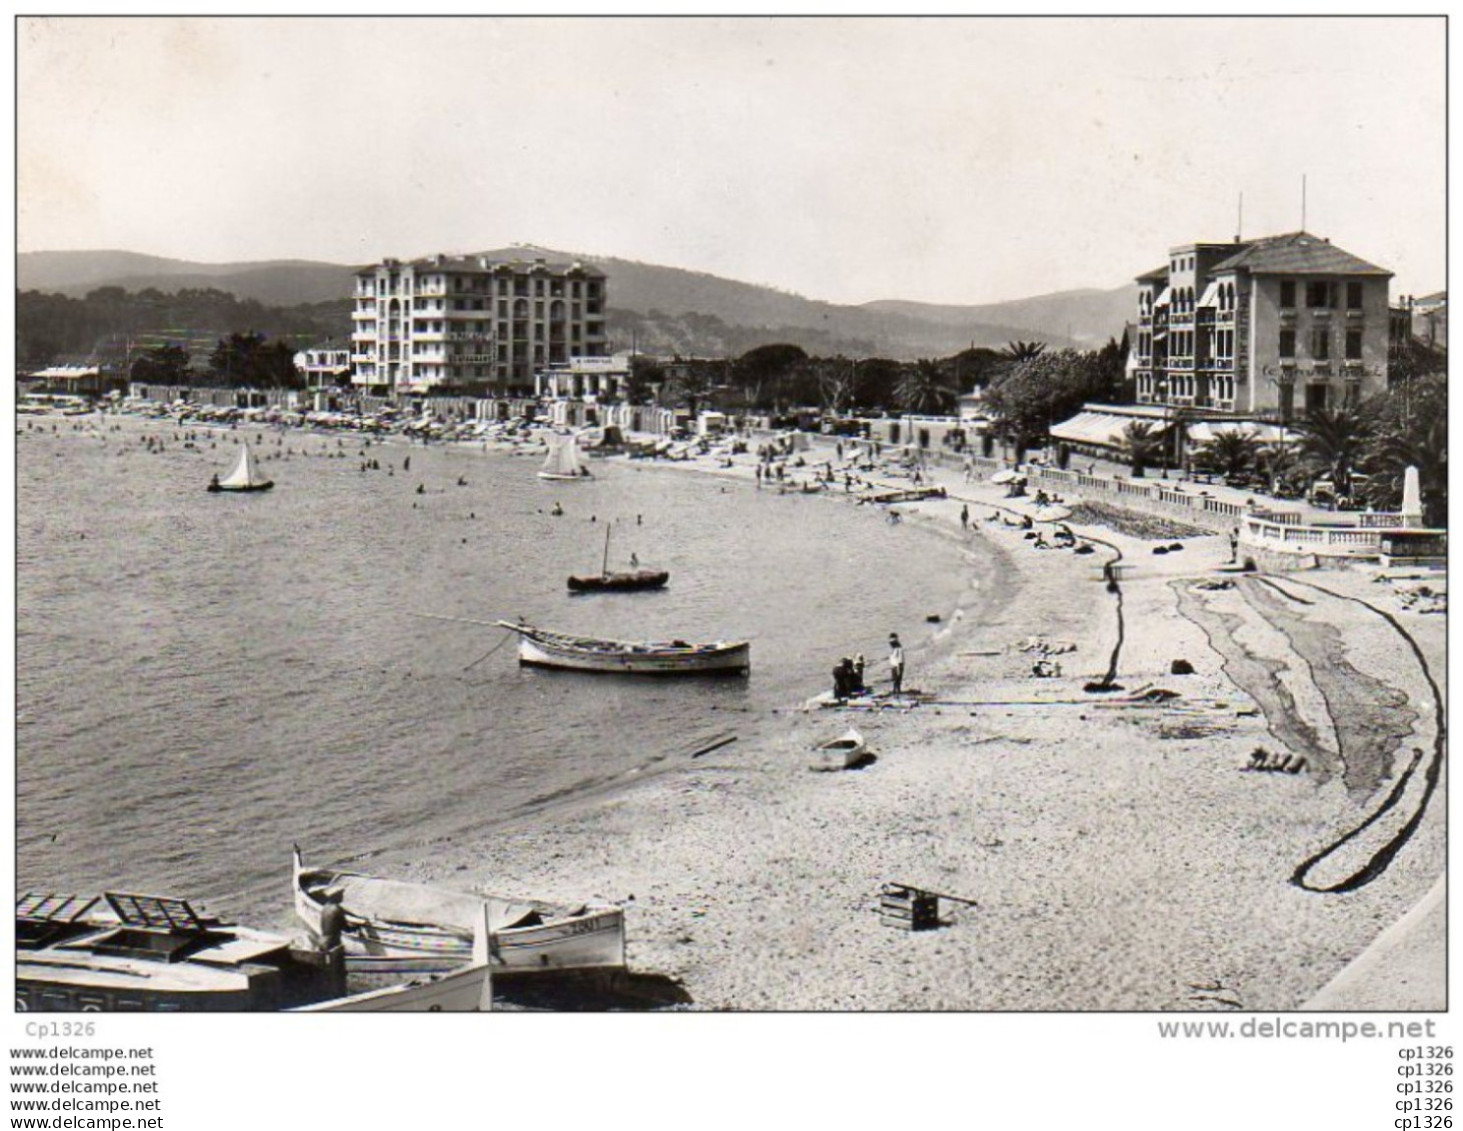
[1129,231,1391,420]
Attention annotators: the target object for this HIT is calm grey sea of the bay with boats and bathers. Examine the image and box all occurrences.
[16,417,971,926]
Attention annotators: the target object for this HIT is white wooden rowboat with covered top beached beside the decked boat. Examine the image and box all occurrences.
[294,849,625,974]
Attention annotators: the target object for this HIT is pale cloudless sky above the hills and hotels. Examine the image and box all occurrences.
[16,16,1447,304]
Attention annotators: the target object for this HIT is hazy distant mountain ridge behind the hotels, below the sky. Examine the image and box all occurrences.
[25,244,1137,358]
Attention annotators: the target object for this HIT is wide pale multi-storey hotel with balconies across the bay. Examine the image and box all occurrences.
[351,250,606,395]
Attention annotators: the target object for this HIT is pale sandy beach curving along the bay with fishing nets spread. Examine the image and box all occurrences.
[157,427,1445,1011]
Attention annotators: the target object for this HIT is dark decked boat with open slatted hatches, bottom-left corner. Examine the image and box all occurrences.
[15,891,345,1012]
